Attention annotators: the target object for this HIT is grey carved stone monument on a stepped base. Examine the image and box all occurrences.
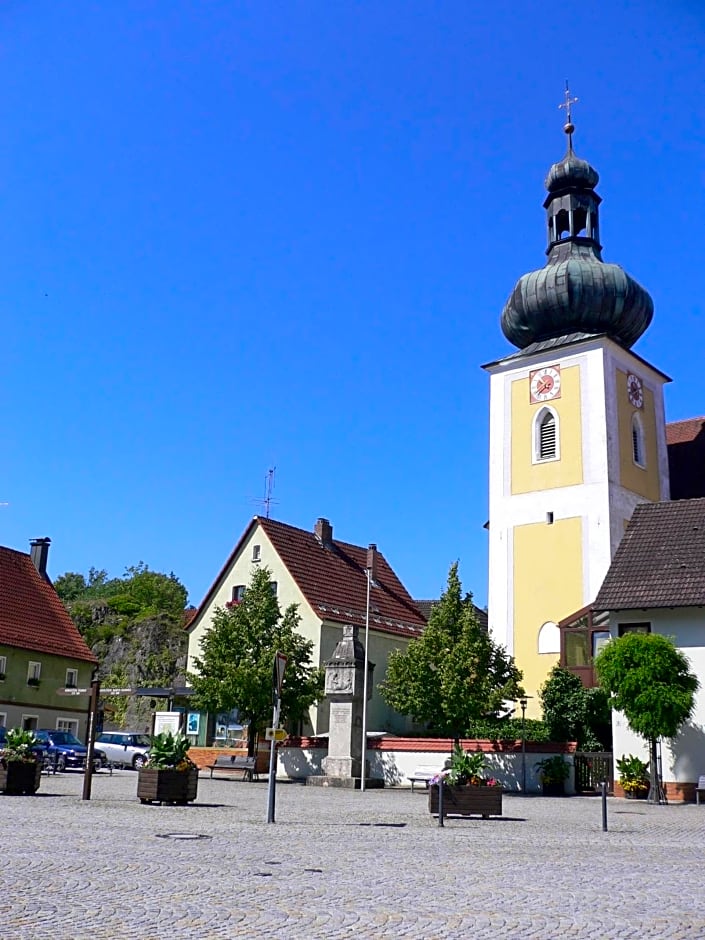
[306,624,384,789]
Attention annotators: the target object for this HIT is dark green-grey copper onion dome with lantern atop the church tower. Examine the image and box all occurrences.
[501,113,654,349]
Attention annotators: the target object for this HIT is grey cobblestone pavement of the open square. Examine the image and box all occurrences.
[0,770,705,940]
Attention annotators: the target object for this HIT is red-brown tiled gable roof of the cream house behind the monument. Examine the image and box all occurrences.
[190,516,426,636]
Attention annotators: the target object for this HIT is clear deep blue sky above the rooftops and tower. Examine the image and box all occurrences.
[0,0,705,604]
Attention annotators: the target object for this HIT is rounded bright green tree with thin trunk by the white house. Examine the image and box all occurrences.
[595,633,700,800]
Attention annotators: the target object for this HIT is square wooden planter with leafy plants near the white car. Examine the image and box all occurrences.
[137,731,198,805]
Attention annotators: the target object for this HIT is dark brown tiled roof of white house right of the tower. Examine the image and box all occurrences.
[594,499,705,610]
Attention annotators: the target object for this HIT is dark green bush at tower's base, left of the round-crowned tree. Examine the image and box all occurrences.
[539,666,612,751]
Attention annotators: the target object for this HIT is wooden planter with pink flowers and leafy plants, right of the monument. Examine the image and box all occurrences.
[428,745,503,819]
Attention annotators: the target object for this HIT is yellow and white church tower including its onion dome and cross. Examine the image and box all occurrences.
[483,97,669,715]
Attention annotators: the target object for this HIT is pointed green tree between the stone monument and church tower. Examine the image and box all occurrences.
[380,563,522,738]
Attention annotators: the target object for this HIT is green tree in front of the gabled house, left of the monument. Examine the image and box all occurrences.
[184,568,323,756]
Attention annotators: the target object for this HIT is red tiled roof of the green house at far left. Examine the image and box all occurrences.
[0,547,98,663]
